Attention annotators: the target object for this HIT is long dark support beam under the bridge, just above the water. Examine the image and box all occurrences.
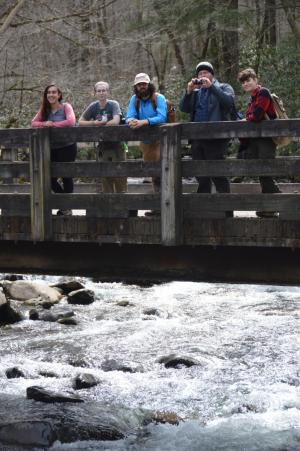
[0,241,300,285]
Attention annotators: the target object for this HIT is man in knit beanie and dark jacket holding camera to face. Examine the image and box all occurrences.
[179,61,234,203]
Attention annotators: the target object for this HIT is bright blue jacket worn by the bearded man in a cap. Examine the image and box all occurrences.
[126,94,167,125]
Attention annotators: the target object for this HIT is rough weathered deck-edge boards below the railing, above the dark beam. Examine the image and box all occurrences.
[0,216,300,249]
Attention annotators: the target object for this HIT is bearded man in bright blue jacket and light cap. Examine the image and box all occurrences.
[126,73,167,216]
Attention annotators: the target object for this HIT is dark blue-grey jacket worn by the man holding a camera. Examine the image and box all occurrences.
[179,79,234,122]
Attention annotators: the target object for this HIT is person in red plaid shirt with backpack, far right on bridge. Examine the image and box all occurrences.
[238,68,281,218]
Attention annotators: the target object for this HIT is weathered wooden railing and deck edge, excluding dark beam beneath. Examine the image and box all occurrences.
[0,119,300,251]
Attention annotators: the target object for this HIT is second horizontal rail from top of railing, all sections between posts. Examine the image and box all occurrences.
[0,157,300,178]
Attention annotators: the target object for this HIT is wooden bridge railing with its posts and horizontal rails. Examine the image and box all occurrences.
[0,119,300,245]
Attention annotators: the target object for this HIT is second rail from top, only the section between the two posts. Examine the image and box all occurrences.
[51,160,160,177]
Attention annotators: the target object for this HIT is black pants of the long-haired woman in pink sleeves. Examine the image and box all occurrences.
[51,143,77,193]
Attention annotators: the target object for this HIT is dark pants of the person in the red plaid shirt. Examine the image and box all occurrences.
[239,138,281,193]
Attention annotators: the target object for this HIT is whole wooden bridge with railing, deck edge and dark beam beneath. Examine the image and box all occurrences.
[0,119,300,283]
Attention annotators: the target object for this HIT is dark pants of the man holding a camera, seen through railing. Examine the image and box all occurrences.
[192,139,230,193]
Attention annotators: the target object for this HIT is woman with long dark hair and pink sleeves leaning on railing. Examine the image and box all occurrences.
[31,84,77,215]
